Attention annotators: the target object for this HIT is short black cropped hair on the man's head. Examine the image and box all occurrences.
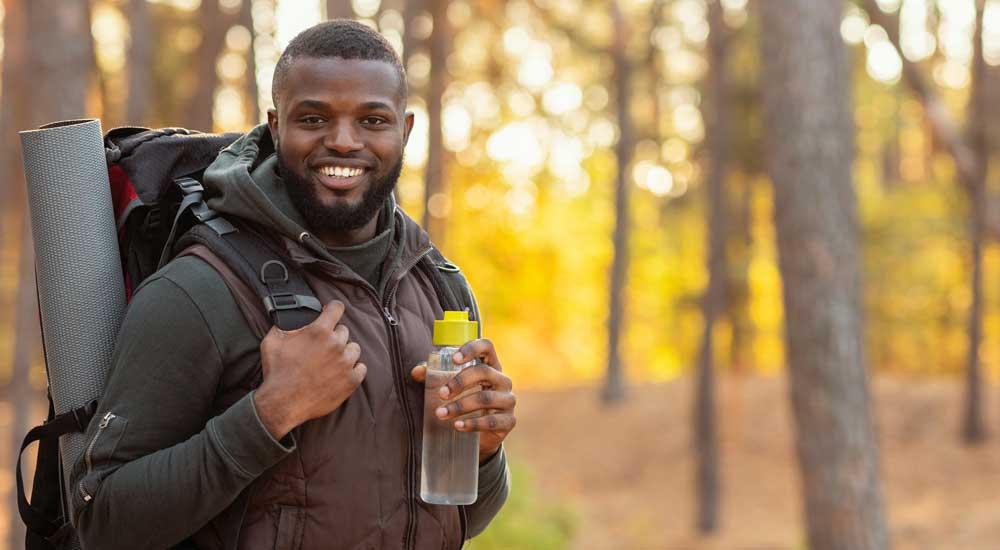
[271,19,407,108]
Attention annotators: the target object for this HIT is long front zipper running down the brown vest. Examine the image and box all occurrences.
[372,247,433,548]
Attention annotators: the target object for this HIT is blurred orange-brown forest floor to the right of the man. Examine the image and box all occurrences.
[508,375,1000,550]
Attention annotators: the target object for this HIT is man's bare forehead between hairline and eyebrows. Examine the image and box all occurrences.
[281,57,404,109]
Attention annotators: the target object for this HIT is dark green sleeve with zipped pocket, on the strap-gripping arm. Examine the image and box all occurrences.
[70,275,294,550]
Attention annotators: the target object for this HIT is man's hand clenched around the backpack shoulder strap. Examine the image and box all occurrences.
[253,300,368,439]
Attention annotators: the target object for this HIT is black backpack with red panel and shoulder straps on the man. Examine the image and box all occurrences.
[15,127,481,550]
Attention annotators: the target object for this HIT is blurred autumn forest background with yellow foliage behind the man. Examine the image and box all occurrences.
[0,0,1000,550]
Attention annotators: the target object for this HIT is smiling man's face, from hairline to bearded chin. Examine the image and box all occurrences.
[267,57,413,233]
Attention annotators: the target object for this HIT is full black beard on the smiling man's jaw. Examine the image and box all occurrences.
[277,149,403,233]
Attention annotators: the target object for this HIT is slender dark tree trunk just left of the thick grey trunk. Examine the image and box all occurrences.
[692,0,730,533]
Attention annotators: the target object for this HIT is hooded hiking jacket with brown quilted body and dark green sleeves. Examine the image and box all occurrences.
[70,125,509,550]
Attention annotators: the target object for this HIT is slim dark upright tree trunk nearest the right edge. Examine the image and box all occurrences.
[962,0,989,444]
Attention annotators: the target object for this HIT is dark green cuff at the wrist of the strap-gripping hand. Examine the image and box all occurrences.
[206,392,295,478]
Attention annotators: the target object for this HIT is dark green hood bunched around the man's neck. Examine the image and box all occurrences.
[202,124,430,272]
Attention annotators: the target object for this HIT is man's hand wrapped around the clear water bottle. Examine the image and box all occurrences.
[410,339,517,464]
